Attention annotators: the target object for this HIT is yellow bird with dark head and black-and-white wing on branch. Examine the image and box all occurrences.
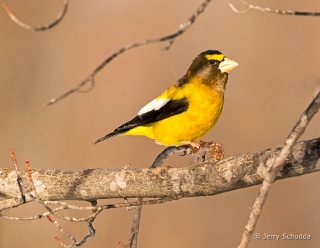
[94,50,238,147]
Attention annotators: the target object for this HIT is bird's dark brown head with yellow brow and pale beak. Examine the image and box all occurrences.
[186,50,238,88]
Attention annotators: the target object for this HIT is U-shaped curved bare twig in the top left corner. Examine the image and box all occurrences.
[2,0,69,31]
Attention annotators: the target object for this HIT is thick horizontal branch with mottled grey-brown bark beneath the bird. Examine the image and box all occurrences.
[0,138,320,210]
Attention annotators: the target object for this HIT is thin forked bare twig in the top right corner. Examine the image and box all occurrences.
[228,0,320,16]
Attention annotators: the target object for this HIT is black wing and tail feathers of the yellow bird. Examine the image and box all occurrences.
[94,97,189,144]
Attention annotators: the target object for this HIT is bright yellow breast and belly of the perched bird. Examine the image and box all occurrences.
[150,80,224,145]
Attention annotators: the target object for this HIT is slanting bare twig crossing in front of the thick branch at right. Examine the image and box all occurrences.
[238,91,320,248]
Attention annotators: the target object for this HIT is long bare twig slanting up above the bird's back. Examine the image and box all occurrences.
[44,0,211,106]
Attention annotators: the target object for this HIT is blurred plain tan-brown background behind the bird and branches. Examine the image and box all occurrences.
[0,0,320,248]
